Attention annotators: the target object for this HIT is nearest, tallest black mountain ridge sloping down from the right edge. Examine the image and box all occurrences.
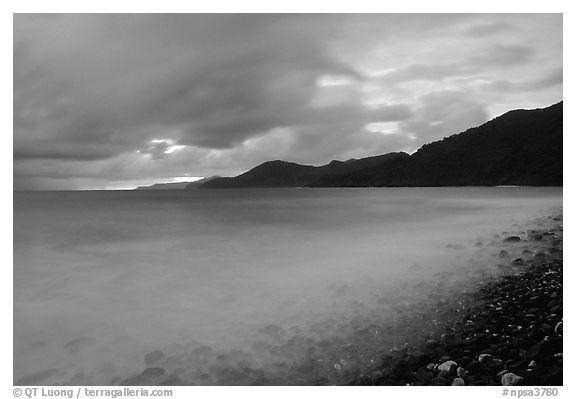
[311,102,563,187]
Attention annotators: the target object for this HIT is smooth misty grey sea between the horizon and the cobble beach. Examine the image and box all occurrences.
[14,187,562,384]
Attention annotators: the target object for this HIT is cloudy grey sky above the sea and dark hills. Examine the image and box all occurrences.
[13,14,563,190]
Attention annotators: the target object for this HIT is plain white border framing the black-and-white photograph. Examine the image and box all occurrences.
[0,0,576,399]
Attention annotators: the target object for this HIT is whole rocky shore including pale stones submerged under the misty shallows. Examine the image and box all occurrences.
[17,215,563,386]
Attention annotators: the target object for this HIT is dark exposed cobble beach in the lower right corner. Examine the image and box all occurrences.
[350,216,563,386]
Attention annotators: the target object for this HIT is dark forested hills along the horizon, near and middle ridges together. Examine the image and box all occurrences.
[199,102,563,188]
